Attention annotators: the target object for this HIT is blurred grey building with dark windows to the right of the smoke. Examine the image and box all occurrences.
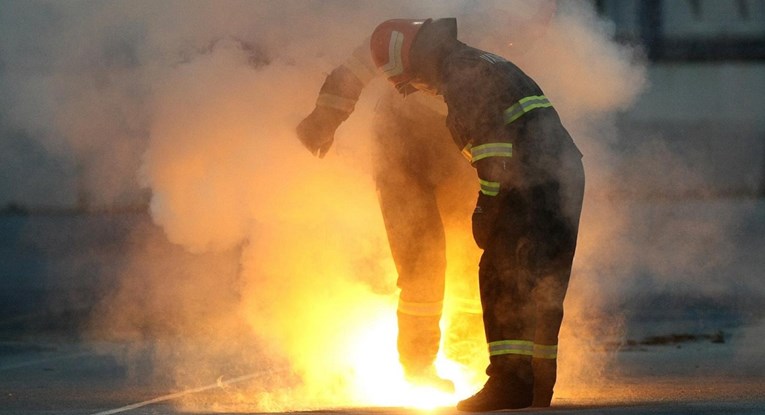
[595,0,765,196]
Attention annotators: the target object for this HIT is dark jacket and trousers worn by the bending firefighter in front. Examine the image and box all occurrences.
[432,40,584,376]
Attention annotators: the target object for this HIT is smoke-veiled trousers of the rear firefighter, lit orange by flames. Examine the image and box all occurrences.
[373,91,471,377]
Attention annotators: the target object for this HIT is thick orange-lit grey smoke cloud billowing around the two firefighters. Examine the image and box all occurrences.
[0,0,668,409]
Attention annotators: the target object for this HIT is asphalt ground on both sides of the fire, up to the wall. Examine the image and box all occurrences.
[0,200,765,415]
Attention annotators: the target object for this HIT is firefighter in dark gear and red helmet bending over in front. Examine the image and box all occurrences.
[370,18,584,412]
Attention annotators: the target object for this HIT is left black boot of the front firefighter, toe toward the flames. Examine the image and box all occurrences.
[457,356,534,412]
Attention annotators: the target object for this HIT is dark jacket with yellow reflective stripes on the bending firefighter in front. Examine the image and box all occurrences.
[439,43,581,196]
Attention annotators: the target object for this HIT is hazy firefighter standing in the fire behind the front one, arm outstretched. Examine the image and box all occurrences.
[297,39,478,392]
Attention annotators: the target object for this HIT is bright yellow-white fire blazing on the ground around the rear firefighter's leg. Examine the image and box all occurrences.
[227,166,487,411]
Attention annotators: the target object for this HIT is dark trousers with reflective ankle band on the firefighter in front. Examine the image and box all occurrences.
[479,154,584,406]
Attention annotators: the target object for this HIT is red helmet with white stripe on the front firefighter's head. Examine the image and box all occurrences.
[370,19,432,93]
